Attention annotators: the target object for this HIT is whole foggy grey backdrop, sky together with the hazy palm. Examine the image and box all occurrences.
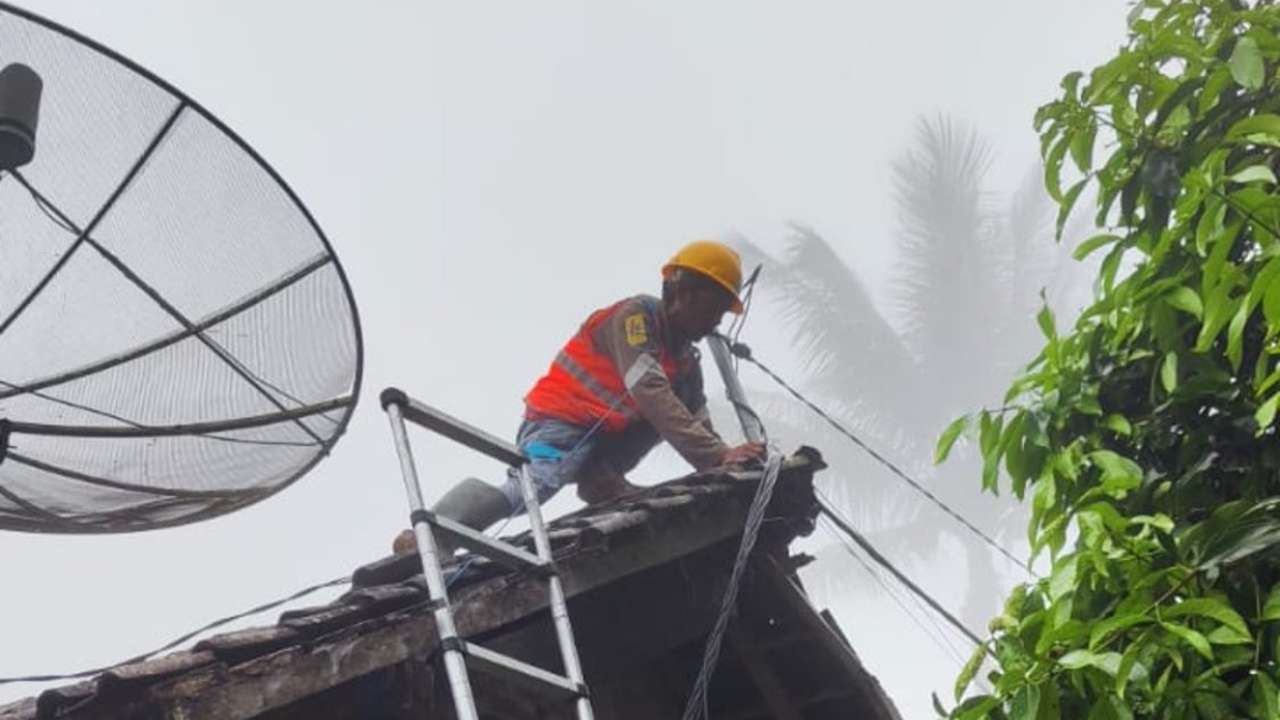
[0,0,1128,719]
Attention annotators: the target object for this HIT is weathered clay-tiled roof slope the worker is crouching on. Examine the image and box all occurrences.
[0,450,896,720]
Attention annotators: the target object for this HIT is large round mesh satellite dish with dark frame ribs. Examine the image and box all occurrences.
[0,3,362,533]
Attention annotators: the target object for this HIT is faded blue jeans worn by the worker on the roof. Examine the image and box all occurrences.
[500,418,658,514]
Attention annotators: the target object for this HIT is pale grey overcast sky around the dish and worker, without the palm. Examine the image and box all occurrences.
[0,0,1128,717]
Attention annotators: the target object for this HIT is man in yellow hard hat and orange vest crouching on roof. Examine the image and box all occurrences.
[396,241,764,552]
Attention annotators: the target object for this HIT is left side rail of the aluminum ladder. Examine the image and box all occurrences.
[387,402,480,720]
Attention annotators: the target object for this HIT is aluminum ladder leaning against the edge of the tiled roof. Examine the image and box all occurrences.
[381,387,594,720]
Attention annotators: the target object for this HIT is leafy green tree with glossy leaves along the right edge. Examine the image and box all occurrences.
[938,0,1280,720]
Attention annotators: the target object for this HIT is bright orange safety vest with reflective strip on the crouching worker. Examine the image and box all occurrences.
[525,300,682,432]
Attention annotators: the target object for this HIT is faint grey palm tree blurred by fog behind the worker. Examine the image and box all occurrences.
[736,112,1083,629]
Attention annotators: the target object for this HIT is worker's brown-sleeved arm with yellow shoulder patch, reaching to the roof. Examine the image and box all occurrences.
[594,301,730,470]
